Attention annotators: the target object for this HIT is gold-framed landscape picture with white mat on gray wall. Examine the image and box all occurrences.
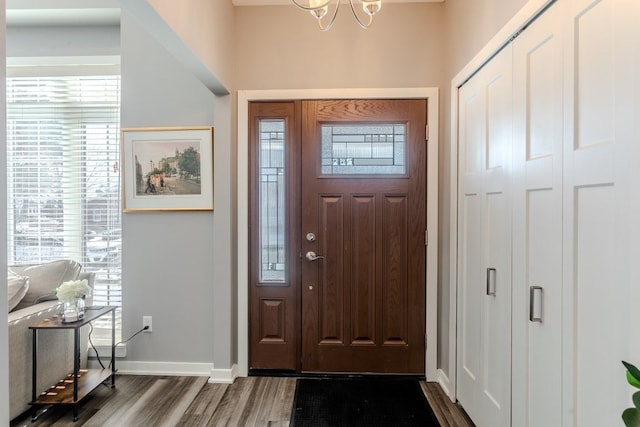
[120,126,214,212]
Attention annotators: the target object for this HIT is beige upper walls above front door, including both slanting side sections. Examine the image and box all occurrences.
[138,0,526,94]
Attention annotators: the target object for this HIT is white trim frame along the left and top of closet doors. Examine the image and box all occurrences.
[448,0,558,402]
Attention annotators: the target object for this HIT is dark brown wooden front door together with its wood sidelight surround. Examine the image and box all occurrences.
[250,100,427,374]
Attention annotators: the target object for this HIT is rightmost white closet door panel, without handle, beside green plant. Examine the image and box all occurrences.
[563,0,640,427]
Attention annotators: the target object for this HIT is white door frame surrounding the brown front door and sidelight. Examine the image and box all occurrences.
[238,88,439,381]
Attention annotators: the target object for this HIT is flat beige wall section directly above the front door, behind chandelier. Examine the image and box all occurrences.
[235,4,445,89]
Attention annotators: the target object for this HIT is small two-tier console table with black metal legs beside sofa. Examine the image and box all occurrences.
[29,306,117,421]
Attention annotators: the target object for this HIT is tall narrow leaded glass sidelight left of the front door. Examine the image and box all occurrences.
[259,119,286,282]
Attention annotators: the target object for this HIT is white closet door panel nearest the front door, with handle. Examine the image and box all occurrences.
[457,46,512,427]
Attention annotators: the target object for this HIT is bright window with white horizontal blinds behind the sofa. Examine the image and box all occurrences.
[6,76,122,338]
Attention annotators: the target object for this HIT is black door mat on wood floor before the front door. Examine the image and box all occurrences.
[291,378,440,427]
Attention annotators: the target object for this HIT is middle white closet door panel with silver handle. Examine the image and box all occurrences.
[512,1,564,427]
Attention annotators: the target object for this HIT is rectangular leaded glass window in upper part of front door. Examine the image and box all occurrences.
[321,124,406,175]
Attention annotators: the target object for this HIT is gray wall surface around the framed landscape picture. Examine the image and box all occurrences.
[121,12,221,367]
